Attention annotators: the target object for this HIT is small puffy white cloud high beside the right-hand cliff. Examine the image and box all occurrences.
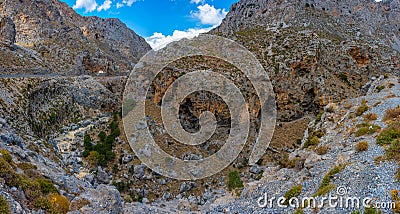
[191,4,228,25]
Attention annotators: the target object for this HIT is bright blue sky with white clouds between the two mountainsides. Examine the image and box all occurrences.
[61,0,238,47]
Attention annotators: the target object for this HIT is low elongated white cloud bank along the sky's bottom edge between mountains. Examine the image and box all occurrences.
[146,26,214,49]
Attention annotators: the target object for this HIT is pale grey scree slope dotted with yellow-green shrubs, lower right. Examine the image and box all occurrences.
[200,76,400,213]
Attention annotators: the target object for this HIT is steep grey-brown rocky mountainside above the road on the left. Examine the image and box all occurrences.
[0,0,150,75]
